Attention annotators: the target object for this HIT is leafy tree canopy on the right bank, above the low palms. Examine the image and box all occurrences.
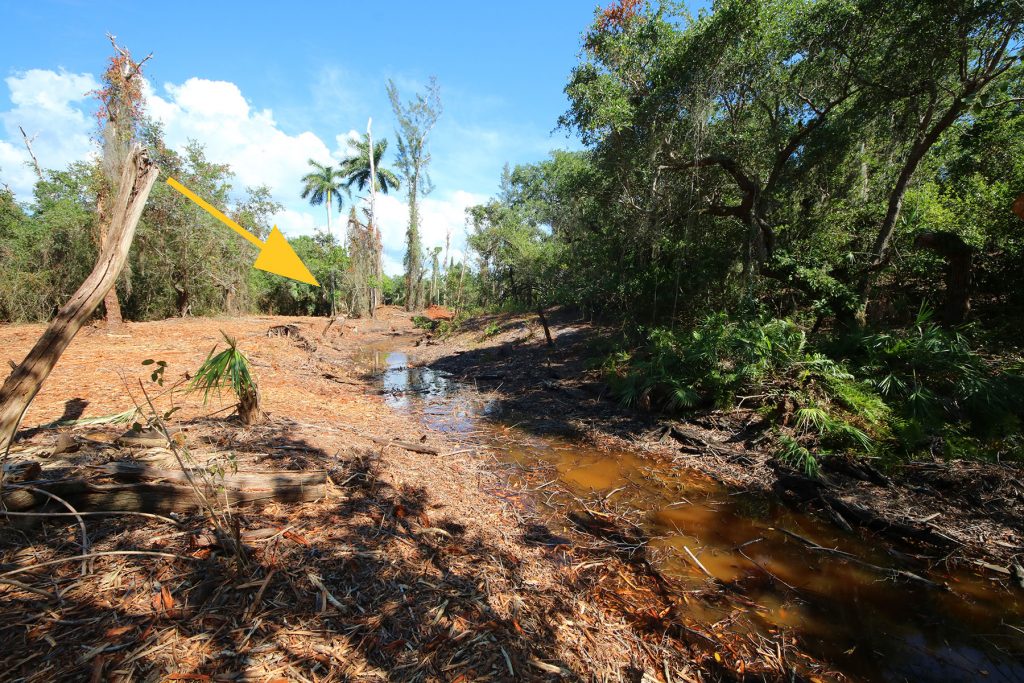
[471,1,1024,325]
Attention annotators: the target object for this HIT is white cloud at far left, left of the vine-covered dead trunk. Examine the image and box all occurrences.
[0,69,98,200]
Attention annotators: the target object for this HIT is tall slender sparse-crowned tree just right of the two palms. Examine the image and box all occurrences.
[387,78,441,310]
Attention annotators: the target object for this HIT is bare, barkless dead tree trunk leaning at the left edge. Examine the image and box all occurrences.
[0,145,159,450]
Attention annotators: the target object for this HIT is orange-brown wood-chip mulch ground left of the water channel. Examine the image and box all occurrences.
[0,309,802,683]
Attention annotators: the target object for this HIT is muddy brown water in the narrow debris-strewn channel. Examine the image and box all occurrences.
[359,348,1024,682]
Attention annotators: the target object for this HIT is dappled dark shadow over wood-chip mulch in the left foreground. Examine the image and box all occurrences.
[0,435,579,681]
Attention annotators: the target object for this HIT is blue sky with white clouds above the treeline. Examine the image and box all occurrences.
[0,0,597,272]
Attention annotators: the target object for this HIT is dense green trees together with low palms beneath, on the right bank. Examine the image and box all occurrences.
[458,0,1024,469]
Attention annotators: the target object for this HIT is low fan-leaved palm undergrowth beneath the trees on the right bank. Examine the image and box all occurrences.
[604,309,1024,462]
